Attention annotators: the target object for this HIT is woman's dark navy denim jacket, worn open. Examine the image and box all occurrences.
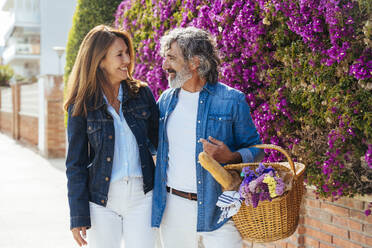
[66,81,159,229]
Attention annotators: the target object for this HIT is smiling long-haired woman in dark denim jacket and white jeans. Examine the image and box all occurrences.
[64,25,159,248]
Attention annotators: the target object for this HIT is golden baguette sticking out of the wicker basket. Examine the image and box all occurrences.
[199,152,233,189]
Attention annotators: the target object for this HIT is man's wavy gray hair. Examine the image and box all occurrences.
[160,27,221,83]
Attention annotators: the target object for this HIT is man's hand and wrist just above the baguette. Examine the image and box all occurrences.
[200,136,242,164]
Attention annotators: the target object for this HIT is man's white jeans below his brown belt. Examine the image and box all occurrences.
[160,193,243,248]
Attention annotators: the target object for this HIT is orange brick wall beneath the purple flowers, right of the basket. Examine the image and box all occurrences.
[245,189,372,248]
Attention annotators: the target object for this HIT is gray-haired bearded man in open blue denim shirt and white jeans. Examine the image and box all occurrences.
[152,27,261,248]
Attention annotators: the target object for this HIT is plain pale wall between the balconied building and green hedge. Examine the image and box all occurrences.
[40,0,77,75]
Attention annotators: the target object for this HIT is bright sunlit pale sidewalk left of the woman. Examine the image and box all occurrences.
[0,133,78,248]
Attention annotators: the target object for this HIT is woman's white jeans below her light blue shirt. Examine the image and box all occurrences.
[87,178,155,248]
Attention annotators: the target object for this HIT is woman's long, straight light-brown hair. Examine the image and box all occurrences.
[64,25,146,116]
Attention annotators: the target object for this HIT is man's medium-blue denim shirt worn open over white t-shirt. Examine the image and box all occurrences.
[151,83,262,232]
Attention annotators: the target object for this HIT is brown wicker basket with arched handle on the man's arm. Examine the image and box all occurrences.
[224,145,305,243]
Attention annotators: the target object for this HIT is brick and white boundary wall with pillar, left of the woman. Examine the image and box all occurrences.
[0,75,66,157]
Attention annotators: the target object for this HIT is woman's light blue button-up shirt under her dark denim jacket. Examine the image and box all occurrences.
[103,85,142,182]
